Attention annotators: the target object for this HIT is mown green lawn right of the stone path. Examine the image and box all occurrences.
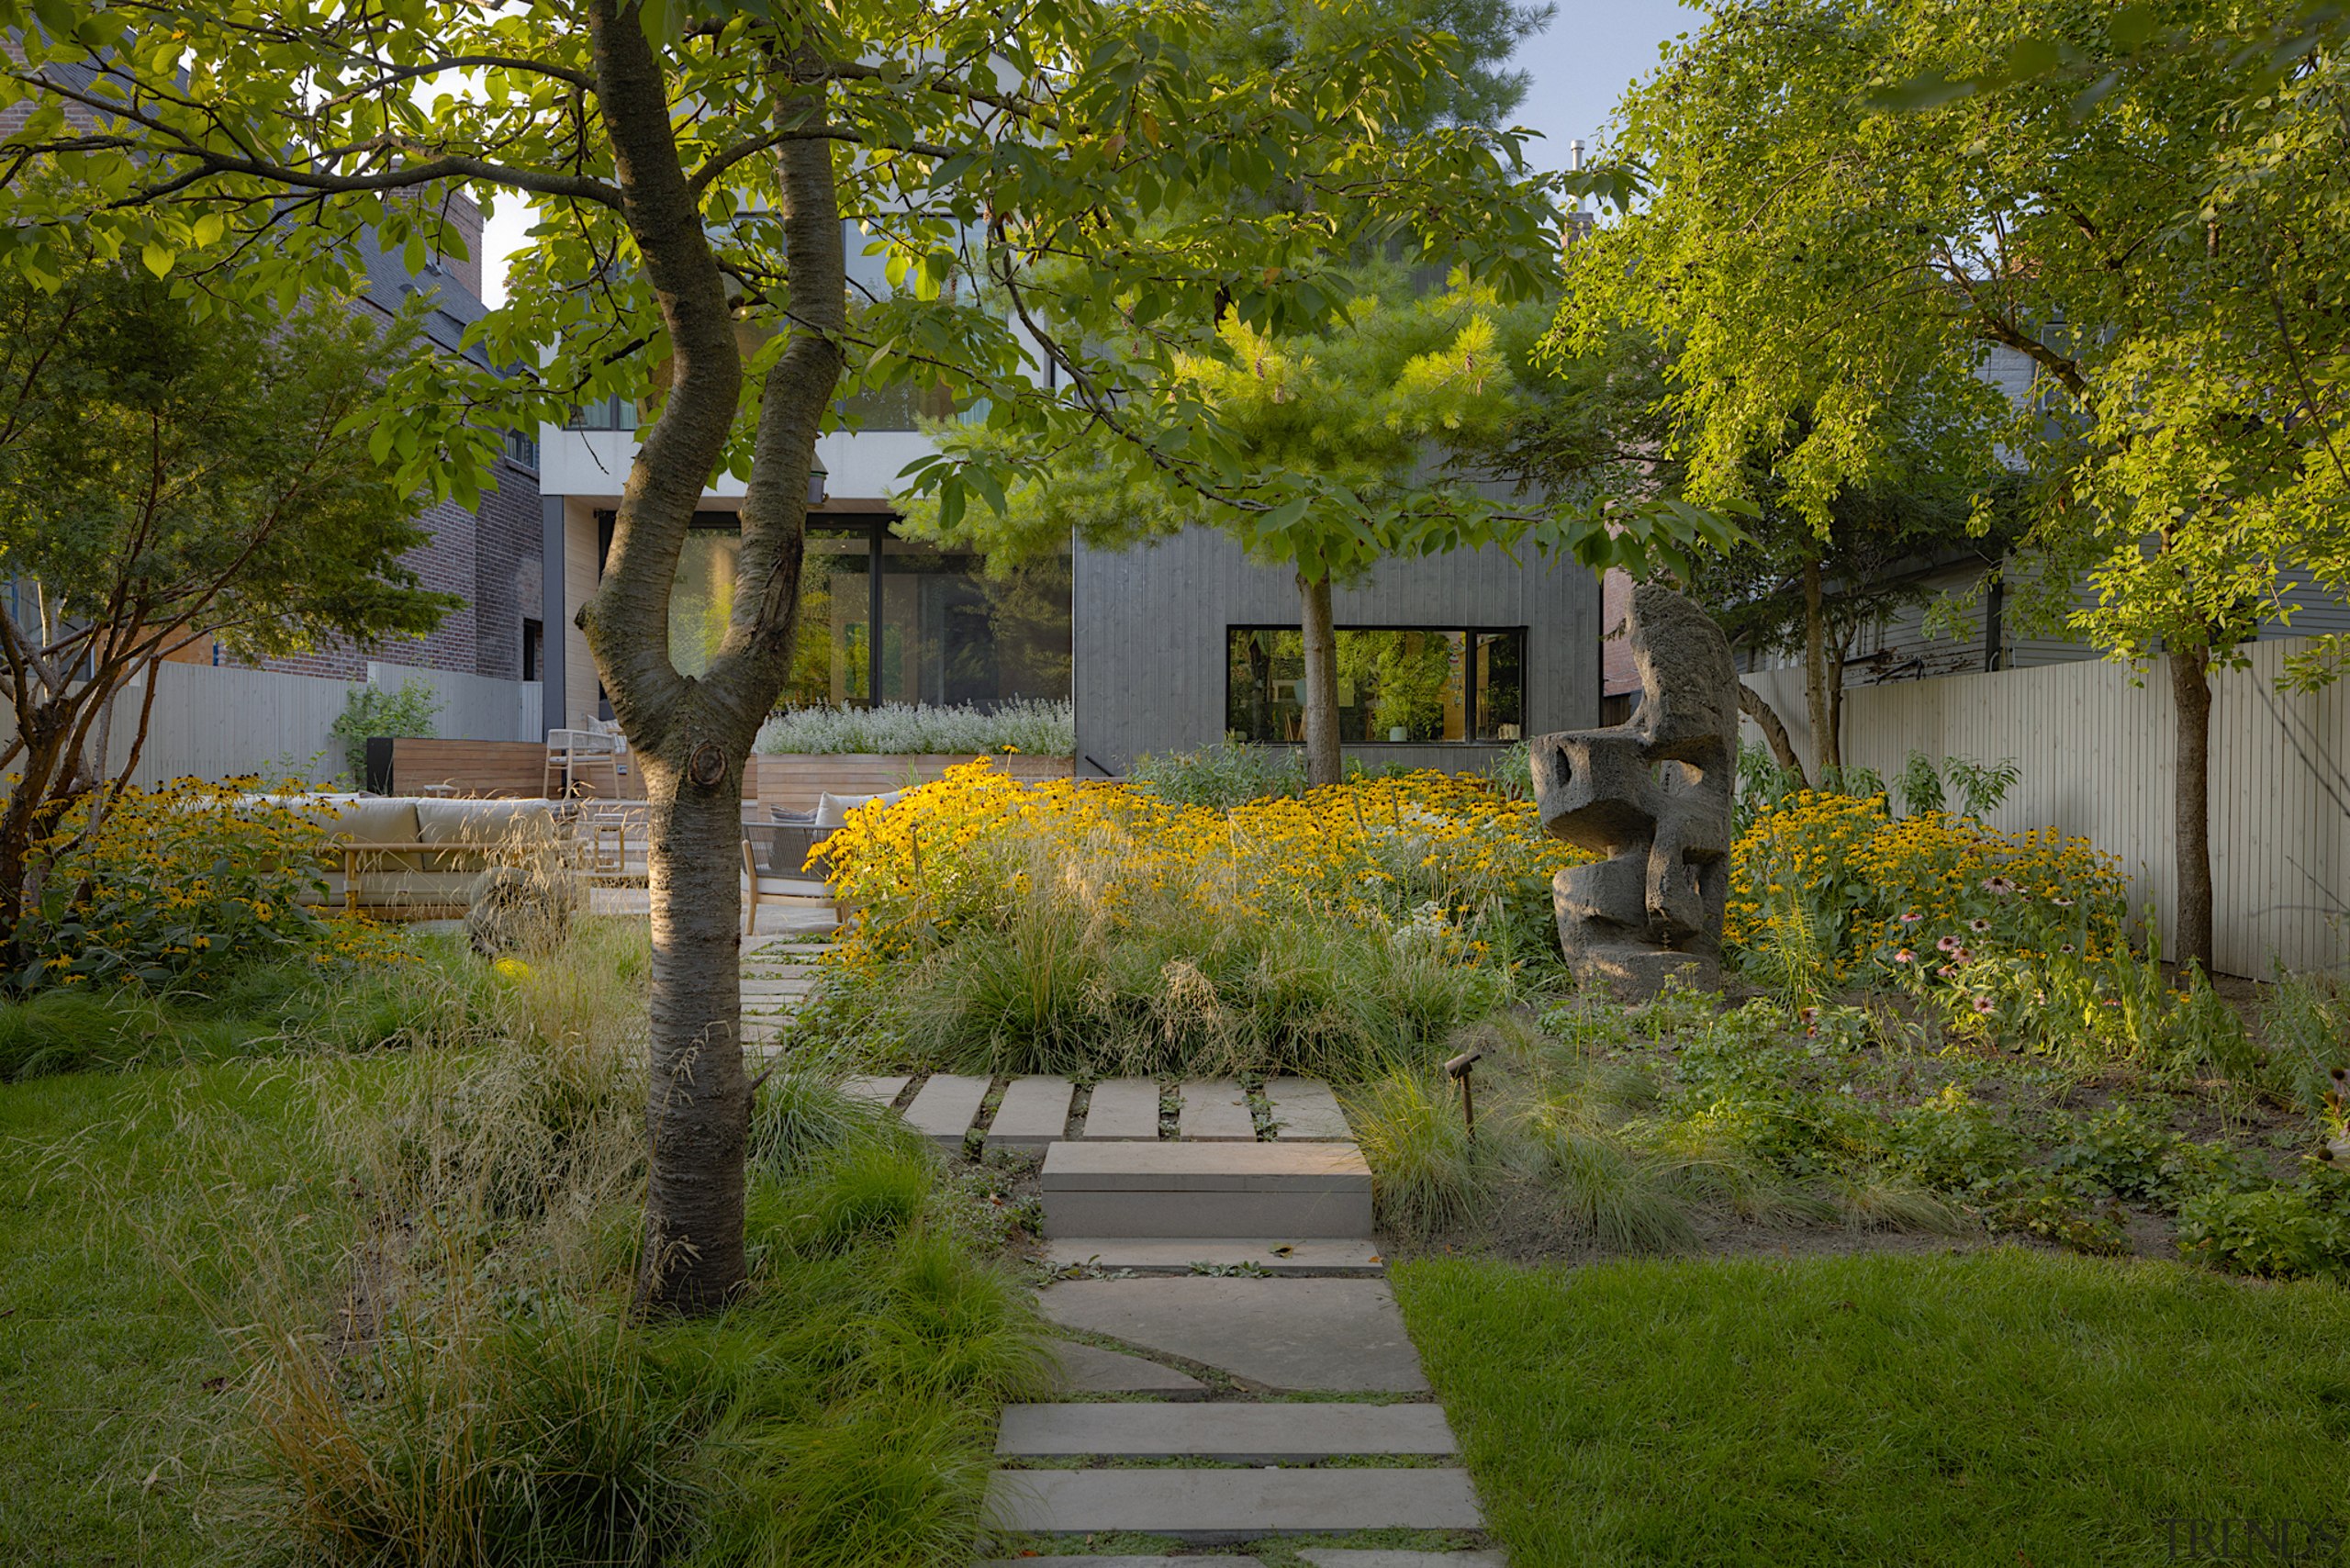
[1396,1249,2350,1568]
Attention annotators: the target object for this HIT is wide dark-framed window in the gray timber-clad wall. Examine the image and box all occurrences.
[1225,625,1525,745]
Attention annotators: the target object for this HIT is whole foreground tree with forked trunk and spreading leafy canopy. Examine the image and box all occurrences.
[0,0,1635,1307]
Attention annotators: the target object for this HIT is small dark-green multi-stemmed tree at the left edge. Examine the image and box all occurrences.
[0,245,456,943]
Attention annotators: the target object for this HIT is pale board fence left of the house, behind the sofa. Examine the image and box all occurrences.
[110,663,545,783]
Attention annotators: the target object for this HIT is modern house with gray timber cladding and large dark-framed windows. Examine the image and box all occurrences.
[538,217,1600,776]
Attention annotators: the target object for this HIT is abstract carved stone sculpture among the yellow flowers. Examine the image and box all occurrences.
[1530,583,1739,1002]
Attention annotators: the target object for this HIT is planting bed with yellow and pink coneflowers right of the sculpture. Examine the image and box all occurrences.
[1348,792,2350,1276]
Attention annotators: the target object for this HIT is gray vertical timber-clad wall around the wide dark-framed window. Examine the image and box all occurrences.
[1074,529,1600,776]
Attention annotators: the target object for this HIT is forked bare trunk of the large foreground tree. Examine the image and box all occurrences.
[580,0,848,1312]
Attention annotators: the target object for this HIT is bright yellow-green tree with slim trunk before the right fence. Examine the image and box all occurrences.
[1562,0,2350,955]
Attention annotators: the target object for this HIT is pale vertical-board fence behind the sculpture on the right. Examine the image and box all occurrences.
[1746,640,2350,976]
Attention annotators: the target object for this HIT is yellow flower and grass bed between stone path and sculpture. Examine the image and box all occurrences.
[799,764,1574,1079]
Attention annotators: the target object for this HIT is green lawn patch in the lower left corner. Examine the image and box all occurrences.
[0,1062,371,1568]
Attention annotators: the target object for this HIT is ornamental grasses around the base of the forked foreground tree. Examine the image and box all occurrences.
[176,922,1046,1568]
